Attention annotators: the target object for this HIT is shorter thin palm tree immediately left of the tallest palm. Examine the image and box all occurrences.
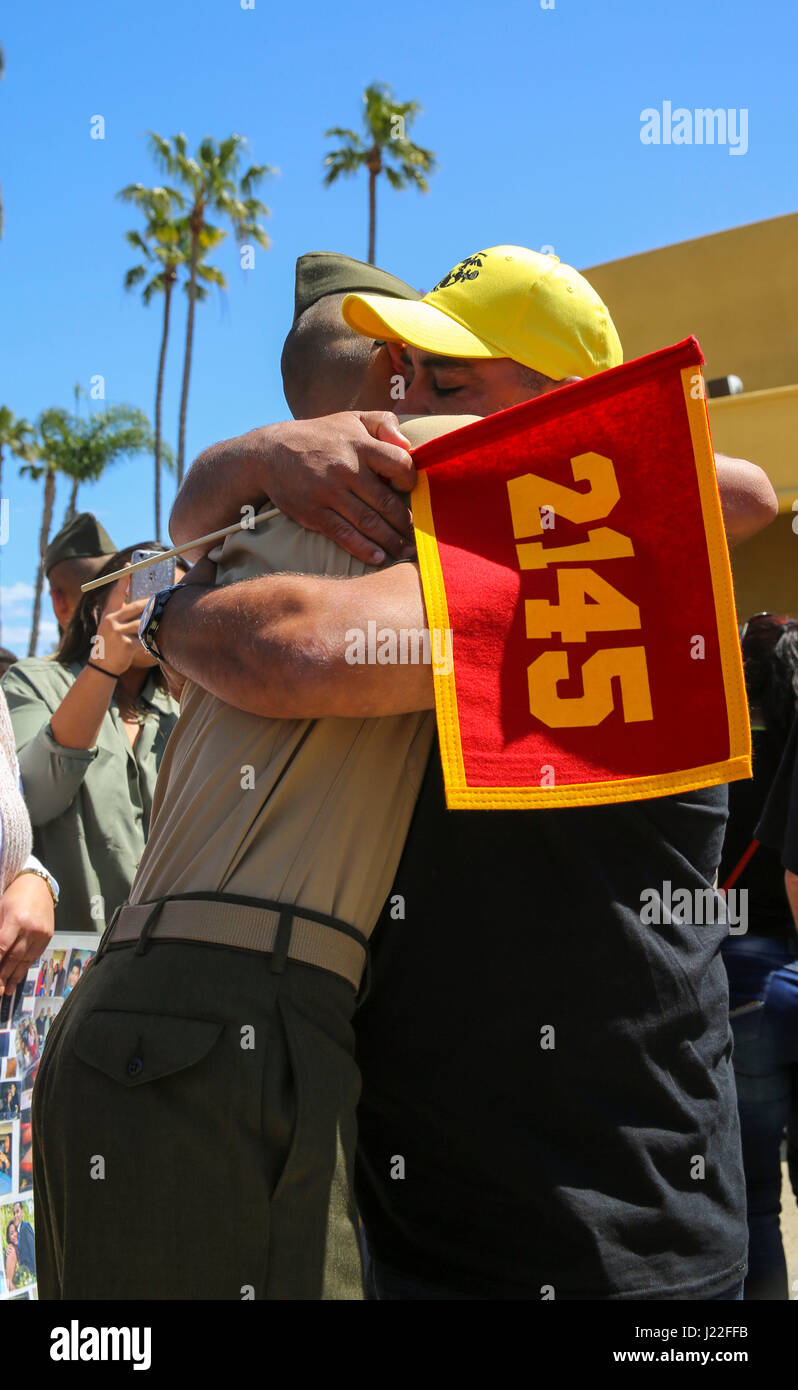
[117,183,188,541]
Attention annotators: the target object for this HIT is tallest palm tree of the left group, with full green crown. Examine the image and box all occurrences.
[150,131,277,487]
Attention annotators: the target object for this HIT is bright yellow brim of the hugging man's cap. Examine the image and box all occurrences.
[341,295,507,357]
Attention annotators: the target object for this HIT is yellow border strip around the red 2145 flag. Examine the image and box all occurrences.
[413,363,751,810]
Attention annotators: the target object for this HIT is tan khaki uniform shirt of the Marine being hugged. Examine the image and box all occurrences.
[131,516,435,934]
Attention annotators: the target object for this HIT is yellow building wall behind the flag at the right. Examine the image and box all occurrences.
[585,213,798,620]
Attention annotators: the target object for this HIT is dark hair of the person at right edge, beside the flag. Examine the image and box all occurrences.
[742,613,798,742]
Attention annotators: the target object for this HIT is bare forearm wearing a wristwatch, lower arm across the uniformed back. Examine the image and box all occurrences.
[157,562,435,719]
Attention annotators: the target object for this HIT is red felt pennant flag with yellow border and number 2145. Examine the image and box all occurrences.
[413,338,751,810]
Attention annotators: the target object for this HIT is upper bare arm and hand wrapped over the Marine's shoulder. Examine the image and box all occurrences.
[170,410,416,564]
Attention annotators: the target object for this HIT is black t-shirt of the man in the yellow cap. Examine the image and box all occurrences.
[356,749,747,1300]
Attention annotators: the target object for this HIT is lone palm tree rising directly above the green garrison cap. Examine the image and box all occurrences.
[324,82,435,265]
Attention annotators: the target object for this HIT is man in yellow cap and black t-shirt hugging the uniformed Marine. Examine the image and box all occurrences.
[145,246,773,1300]
